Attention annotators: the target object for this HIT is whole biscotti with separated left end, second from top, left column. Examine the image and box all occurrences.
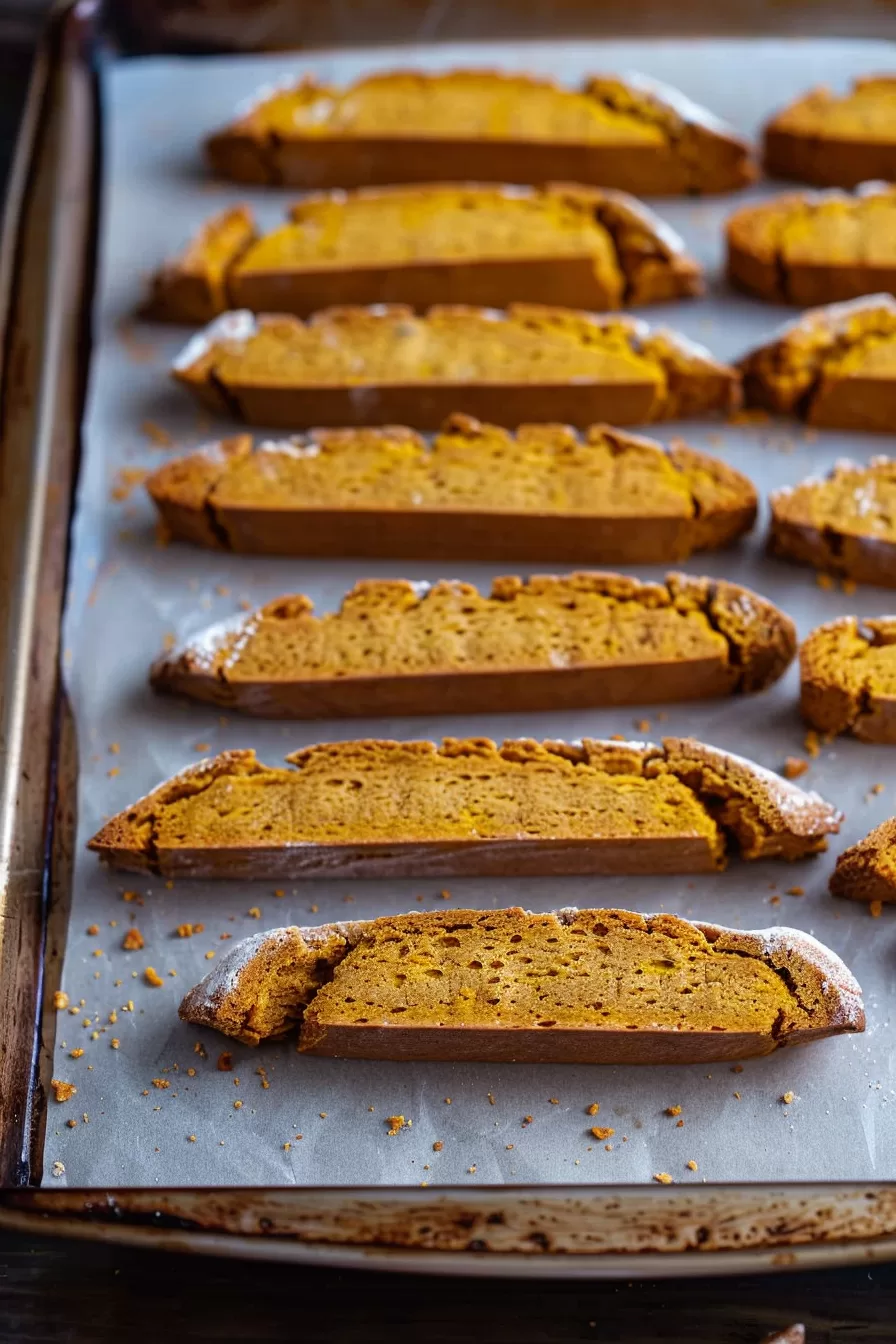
[149,183,703,323]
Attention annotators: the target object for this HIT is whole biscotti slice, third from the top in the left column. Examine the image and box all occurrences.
[172,304,740,430]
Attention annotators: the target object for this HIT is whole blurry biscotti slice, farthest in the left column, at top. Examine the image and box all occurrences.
[206,70,756,196]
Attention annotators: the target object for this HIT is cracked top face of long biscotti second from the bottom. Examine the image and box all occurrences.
[90,738,841,871]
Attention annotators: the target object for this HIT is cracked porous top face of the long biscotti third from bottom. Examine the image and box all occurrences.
[152,573,795,694]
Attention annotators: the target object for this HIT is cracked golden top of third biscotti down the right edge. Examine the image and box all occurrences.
[737,294,896,417]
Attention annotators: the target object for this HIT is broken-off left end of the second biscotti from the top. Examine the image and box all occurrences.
[145,206,257,324]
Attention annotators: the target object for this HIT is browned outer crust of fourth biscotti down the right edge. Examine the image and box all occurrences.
[768,457,896,587]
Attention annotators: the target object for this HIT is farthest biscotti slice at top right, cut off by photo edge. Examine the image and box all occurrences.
[764,74,896,187]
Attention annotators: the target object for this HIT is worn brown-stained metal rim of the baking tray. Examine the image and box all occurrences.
[7,0,896,1278]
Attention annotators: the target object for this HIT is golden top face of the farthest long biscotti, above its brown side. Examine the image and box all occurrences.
[207,70,755,191]
